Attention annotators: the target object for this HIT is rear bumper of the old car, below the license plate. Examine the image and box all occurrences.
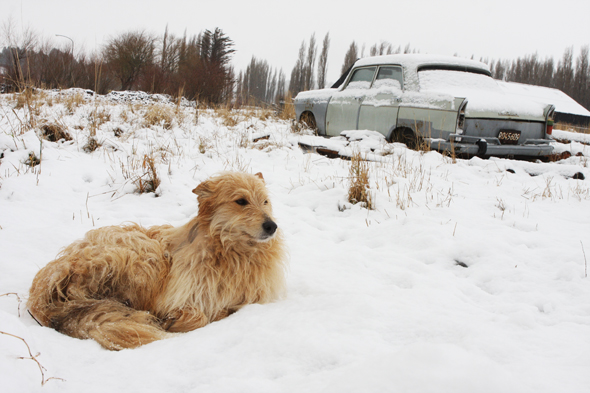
[430,134,553,157]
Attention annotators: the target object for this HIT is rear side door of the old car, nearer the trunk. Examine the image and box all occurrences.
[357,66,403,136]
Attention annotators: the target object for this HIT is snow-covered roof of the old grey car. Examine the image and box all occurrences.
[355,54,490,75]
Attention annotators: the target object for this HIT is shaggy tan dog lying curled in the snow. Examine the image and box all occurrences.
[27,173,285,350]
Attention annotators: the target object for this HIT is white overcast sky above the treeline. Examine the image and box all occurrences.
[0,0,590,81]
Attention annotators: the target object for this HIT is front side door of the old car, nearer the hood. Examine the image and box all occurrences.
[326,67,377,136]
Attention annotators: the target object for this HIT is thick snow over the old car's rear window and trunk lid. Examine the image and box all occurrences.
[418,70,549,121]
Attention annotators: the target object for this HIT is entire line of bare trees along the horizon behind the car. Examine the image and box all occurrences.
[0,21,590,110]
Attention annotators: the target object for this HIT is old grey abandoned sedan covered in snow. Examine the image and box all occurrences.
[294,54,555,157]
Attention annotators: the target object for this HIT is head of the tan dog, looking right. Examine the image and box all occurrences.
[193,172,277,242]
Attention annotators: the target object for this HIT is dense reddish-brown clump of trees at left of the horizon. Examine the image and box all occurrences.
[0,23,235,104]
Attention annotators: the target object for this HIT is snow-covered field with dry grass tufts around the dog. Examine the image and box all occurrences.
[0,89,590,393]
